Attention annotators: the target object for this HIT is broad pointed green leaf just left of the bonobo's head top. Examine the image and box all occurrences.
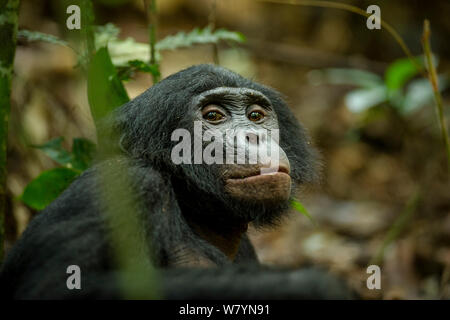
[88,48,130,124]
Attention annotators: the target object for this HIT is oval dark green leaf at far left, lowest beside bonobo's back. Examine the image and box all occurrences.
[20,168,79,210]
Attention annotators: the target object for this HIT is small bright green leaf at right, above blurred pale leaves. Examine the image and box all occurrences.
[384,57,423,91]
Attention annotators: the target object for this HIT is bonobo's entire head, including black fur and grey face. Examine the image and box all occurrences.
[113,65,318,226]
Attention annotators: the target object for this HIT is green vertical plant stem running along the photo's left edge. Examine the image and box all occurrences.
[0,0,19,263]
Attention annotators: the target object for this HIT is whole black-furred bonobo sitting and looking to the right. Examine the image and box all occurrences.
[0,65,351,299]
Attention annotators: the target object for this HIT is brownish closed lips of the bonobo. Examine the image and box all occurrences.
[225,172,291,204]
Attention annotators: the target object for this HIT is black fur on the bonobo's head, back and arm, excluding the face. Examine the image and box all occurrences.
[0,65,348,299]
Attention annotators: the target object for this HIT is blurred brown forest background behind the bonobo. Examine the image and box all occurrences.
[6,0,450,299]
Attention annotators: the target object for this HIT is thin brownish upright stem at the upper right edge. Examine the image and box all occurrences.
[422,20,450,171]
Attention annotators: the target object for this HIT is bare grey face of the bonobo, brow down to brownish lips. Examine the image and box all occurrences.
[194,87,291,205]
